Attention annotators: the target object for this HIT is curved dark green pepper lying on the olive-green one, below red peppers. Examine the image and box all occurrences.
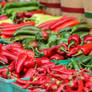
[13,29,38,36]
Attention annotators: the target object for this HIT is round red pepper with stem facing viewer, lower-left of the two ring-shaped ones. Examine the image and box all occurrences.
[56,43,68,55]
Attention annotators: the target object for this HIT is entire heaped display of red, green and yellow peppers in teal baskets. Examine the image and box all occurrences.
[0,0,92,92]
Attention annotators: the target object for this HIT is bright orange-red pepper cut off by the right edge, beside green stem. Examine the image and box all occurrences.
[79,43,92,55]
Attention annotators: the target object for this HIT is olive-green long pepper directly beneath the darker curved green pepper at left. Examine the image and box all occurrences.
[11,35,35,42]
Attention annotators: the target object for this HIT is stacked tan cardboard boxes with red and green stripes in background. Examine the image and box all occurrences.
[0,0,92,24]
